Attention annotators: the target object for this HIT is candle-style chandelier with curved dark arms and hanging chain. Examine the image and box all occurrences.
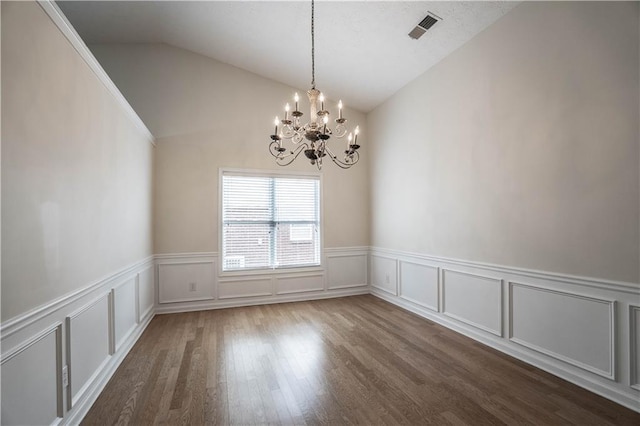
[269,0,360,170]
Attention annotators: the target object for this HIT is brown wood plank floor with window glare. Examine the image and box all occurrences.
[83,296,640,425]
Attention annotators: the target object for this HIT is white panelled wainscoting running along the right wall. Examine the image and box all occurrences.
[370,248,640,412]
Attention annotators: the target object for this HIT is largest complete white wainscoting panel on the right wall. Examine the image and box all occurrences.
[509,282,615,380]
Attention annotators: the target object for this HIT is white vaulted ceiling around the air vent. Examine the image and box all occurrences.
[58,0,518,112]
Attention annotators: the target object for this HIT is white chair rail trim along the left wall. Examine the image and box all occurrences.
[0,256,154,340]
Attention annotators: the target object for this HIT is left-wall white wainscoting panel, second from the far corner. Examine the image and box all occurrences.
[111,276,138,351]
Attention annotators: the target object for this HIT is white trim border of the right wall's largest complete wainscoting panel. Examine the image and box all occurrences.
[509,281,616,381]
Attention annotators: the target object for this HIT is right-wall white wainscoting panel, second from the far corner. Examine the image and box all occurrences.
[400,261,439,312]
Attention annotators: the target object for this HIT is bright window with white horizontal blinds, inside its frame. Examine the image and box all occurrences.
[221,171,320,271]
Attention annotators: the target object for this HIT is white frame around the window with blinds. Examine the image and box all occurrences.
[217,167,325,277]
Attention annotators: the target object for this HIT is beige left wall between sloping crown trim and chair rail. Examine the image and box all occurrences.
[2,2,153,321]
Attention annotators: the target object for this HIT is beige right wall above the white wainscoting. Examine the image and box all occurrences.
[367,2,640,282]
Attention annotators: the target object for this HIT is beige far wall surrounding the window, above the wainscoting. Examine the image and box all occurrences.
[91,44,369,253]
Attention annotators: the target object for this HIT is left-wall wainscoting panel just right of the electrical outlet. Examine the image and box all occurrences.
[66,293,113,409]
